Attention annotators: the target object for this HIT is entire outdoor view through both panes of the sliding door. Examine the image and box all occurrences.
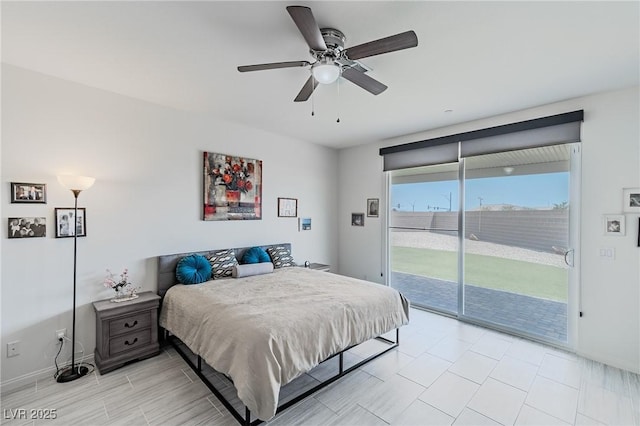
[389,144,577,346]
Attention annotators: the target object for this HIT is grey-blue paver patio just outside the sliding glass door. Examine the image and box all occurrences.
[391,271,567,342]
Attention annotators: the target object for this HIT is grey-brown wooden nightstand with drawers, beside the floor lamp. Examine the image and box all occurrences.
[93,291,160,374]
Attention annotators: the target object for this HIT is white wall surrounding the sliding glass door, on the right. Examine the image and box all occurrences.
[338,87,640,372]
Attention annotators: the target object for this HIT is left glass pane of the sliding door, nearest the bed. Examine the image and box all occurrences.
[389,163,459,315]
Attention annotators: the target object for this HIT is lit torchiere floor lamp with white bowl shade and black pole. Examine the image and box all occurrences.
[56,175,95,383]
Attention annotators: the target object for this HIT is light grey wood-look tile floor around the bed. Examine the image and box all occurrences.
[1,309,640,426]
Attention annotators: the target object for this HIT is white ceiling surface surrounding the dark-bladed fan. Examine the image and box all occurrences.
[1,1,640,148]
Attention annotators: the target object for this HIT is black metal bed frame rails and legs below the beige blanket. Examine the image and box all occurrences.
[165,328,400,426]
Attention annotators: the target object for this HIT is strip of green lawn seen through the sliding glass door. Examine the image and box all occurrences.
[391,247,567,303]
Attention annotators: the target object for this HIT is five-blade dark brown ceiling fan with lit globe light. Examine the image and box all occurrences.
[238,6,418,102]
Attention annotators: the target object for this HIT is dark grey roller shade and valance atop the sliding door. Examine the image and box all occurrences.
[380,110,584,171]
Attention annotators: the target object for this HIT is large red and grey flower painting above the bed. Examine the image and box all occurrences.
[202,152,262,220]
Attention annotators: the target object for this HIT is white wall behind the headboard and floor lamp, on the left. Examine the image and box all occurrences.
[0,64,337,389]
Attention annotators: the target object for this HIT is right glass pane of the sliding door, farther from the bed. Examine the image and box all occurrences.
[460,145,573,344]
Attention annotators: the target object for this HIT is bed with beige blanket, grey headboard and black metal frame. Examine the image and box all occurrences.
[158,244,409,424]
